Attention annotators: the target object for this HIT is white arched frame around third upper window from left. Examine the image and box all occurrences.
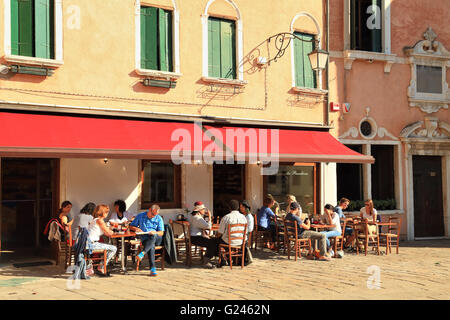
[201,0,244,81]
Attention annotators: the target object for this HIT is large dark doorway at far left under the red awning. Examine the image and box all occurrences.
[0,158,57,257]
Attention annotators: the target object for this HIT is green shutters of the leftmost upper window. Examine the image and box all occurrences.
[11,0,55,59]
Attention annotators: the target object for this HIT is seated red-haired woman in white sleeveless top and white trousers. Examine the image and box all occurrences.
[88,204,117,275]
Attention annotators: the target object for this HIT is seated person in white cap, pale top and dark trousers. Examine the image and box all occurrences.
[190,201,217,269]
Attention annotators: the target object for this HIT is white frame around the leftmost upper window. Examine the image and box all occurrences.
[3,0,64,67]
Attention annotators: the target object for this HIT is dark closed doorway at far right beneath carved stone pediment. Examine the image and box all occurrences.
[413,156,445,238]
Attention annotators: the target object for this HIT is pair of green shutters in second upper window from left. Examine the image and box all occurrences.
[141,7,173,72]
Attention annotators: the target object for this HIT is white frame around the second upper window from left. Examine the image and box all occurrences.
[134,0,181,78]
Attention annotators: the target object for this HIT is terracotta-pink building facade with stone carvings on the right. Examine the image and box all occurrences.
[330,0,450,240]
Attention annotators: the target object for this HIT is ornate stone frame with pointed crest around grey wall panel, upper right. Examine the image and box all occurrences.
[404,27,450,114]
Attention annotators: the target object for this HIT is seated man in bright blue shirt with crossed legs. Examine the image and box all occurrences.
[130,204,164,277]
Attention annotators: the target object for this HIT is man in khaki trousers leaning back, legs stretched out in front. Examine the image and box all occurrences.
[285,202,331,261]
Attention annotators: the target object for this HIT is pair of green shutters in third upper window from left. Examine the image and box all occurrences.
[208,17,236,79]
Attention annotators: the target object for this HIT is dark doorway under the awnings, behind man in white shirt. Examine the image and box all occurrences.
[213,164,245,217]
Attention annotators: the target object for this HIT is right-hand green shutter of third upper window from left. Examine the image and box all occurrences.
[220,20,236,79]
